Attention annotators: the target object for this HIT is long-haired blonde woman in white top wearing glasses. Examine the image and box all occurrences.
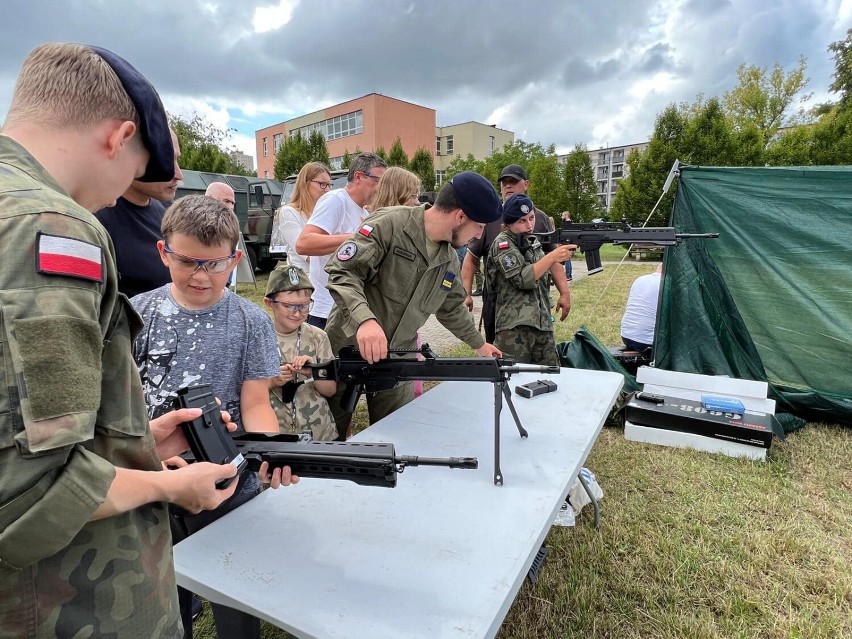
[271,162,331,273]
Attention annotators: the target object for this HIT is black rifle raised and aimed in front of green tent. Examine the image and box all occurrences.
[535,220,719,275]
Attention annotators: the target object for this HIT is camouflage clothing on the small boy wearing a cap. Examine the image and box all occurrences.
[269,324,337,441]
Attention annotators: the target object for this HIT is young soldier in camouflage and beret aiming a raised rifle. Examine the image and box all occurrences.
[485,194,576,366]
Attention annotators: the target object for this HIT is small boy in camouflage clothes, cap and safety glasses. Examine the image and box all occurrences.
[263,266,337,441]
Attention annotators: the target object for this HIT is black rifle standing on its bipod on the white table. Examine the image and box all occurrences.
[282,344,559,485]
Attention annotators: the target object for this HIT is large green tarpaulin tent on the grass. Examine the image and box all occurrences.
[654,166,852,425]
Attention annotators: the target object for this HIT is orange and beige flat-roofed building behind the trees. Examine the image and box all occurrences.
[255,93,435,177]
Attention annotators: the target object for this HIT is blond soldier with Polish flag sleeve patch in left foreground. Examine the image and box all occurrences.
[0,44,272,638]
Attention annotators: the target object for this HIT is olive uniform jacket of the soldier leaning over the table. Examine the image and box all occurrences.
[325,205,485,352]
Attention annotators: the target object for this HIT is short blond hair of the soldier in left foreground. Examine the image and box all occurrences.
[5,43,140,127]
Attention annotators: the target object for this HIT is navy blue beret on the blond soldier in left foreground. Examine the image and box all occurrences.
[86,45,175,182]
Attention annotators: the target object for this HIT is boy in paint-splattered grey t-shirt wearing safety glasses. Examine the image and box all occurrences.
[130,195,278,639]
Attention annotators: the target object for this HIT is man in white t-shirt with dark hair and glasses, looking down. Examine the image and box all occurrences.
[296,153,388,329]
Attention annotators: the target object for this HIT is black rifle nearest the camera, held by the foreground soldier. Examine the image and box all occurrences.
[175,384,479,488]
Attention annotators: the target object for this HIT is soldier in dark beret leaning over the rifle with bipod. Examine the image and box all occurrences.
[326,171,502,440]
